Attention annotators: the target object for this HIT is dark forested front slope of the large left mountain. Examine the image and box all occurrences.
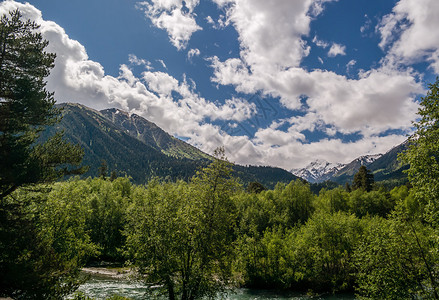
[42,104,197,183]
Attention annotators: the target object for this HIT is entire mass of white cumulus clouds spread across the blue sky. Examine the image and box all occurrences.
[0,0,439,169]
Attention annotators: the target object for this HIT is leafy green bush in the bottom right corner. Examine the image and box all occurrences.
[355,208,439,299]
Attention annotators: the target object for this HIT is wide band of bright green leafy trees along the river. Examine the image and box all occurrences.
[3,160,430,299]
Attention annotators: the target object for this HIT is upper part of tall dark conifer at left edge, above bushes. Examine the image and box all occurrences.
[0,10,82,198]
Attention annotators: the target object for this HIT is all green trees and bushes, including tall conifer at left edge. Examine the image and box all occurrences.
[0,11,439,300]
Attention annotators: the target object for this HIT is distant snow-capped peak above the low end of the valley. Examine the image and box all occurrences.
[291,159,345,183]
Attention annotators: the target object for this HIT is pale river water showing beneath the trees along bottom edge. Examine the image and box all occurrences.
[71,275,355,300]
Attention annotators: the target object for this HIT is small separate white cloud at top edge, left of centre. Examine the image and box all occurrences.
[137,0,202,50]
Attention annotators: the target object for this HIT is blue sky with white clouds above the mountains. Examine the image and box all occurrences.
[0,0,439,170]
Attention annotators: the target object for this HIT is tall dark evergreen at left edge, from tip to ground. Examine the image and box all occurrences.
[0,10,84,299]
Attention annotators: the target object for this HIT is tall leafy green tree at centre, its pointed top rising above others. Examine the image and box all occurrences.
[125,150,241,299]
